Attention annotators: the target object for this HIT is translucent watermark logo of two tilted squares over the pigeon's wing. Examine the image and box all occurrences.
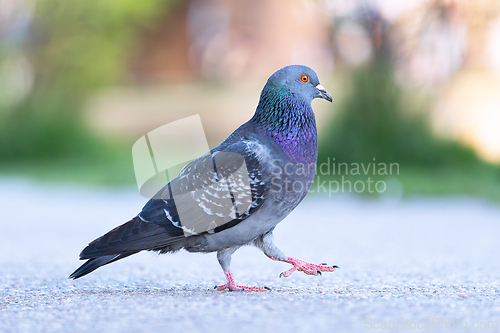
[132,115,252,237]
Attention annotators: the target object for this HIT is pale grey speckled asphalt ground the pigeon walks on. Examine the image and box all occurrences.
[0,179,500,333]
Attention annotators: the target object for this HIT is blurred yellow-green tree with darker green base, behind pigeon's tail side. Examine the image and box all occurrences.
[0,0,180,161]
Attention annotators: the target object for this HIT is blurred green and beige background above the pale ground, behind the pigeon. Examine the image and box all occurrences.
[0,0,500,201]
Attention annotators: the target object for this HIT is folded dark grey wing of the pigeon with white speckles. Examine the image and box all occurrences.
[139,141,271,237]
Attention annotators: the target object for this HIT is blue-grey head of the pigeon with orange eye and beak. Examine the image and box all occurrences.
[262,65,332,105]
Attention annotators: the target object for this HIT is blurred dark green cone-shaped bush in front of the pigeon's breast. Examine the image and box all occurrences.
[319,57,476,167]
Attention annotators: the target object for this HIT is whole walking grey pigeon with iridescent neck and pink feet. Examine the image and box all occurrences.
[69,65,338,291]
